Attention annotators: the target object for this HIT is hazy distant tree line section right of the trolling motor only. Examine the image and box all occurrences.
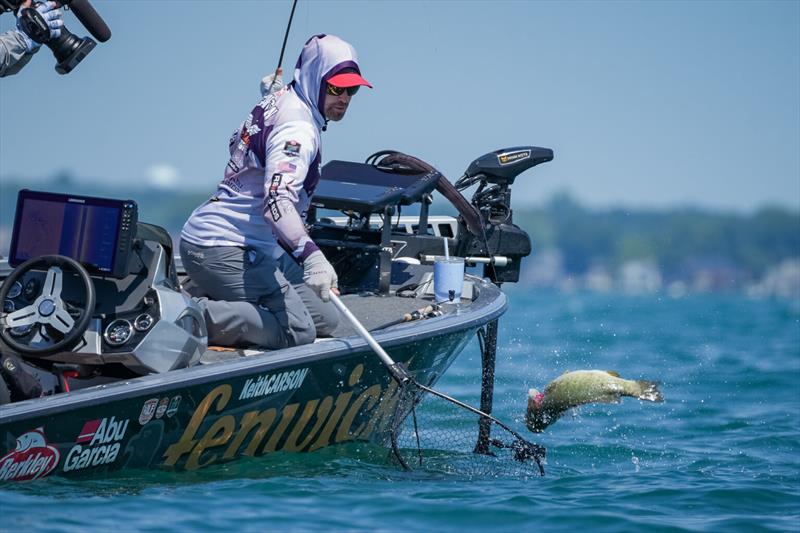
[514,194,800,279]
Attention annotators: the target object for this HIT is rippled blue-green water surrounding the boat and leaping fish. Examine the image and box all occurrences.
[0,287,800,532]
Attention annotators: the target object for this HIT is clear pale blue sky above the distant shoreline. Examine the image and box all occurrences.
[0,0,800,212]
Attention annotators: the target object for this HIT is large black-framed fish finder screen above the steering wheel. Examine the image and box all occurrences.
[9,191,122,272]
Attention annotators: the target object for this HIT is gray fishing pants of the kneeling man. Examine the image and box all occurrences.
[180,239,339,349]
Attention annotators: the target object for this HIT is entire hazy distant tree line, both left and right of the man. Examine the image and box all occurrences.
[0,179,800,279]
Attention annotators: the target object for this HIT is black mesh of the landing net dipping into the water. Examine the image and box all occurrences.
[391,382,545,477]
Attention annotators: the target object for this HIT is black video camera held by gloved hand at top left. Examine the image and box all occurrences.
[0,0,111,74]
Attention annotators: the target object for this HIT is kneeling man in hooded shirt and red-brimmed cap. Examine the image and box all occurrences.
[180,35,372,349]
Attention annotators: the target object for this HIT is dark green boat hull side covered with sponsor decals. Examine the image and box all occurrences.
[0,284,505,482]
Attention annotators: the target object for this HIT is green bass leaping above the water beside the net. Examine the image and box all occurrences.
[525,370,664,433]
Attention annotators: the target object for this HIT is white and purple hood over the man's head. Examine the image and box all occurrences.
[292,34,371,128]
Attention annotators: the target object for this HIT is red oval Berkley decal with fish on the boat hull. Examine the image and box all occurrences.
[0,427,61,481]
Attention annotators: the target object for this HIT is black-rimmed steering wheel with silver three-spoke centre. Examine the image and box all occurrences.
[0,255,96,357]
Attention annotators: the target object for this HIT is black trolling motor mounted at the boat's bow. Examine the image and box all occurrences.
[455,146,553,284]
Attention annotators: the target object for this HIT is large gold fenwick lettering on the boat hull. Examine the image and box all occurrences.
[164,365,398,470]
